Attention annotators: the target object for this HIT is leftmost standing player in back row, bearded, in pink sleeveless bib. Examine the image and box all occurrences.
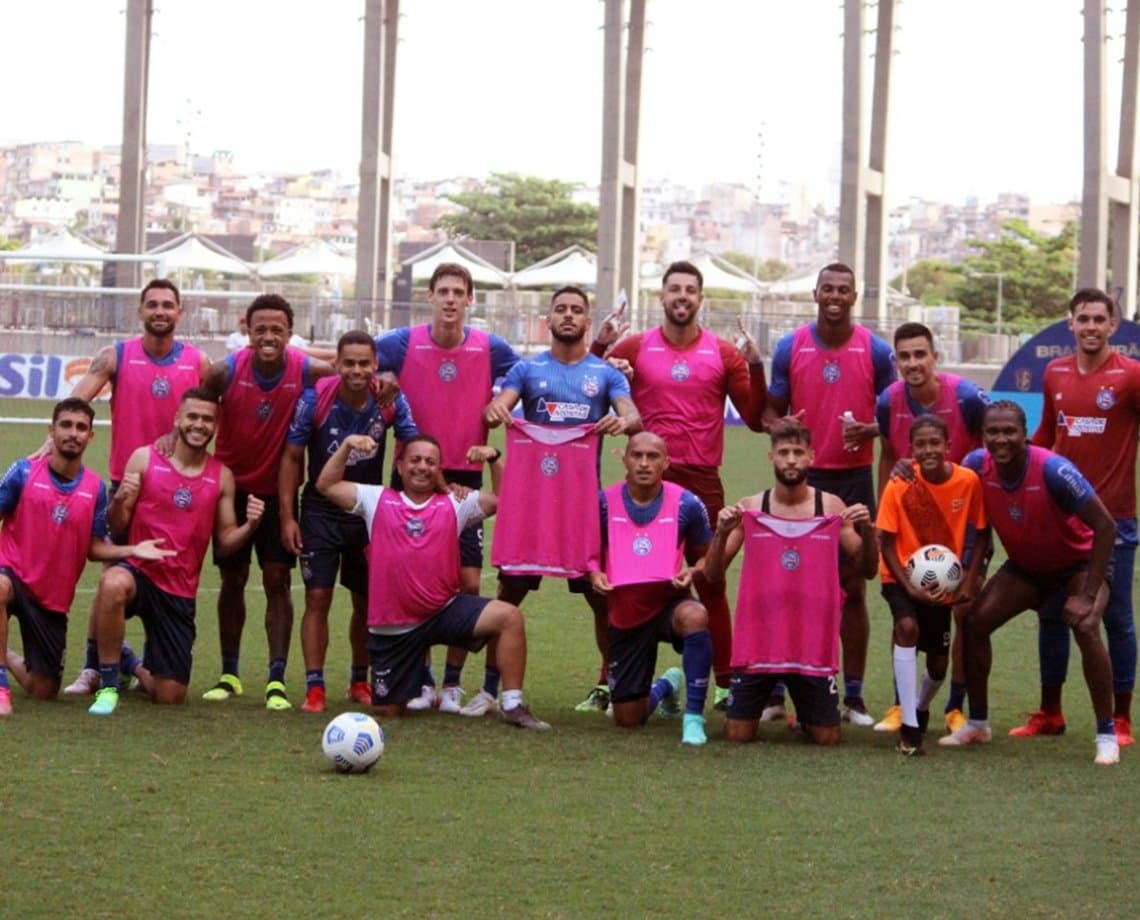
[57,278,210,694]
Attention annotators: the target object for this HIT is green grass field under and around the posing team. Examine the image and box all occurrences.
[0,400,1140,918]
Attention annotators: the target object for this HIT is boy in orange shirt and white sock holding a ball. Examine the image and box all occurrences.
[876,415,990,756]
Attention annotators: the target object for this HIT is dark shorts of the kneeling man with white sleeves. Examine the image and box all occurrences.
[368,594,490,706]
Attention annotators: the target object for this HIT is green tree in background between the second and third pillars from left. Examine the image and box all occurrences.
[434,172,597,268]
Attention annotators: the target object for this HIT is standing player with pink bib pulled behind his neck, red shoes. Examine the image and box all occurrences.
[277,329,420,713]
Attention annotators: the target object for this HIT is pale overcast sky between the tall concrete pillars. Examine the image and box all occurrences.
[0,0,1123,203]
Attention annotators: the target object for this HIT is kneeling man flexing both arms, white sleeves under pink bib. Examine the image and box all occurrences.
[317,434,551,731]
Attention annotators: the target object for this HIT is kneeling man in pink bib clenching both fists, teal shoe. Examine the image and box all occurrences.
[88,388,264,716]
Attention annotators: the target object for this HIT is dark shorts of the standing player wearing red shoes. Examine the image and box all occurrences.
[300,498,368,594]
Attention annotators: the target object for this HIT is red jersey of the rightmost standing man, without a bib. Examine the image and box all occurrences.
[1033,351,1140,520]
